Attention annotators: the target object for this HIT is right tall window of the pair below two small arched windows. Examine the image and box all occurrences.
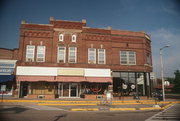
[68,47,77,63]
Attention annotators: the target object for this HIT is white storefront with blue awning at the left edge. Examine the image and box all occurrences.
[0,60,16,97]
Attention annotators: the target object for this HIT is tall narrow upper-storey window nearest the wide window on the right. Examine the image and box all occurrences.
[98,49,106,64]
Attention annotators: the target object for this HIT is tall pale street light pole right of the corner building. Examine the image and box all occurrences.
[160,45,170,101]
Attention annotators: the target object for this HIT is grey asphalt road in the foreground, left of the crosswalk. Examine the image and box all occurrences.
[0,105,158,121]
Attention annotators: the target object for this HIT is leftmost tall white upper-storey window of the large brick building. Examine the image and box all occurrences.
[26,45,35,62]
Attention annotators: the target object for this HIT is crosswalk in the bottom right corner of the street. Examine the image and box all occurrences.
[145,104,180,121]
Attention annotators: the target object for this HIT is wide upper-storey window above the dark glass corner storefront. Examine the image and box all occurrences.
[120,51,136,65]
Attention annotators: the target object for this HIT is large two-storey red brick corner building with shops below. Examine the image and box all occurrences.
[16,17,152,99]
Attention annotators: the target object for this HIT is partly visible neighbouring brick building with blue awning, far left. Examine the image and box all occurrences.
[0,48,18,96]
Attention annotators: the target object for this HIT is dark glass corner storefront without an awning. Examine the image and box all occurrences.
[112,72,151,97]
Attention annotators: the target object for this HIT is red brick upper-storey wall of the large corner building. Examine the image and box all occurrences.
[18,19,152,72]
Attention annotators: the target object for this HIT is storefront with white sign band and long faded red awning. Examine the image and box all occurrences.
[16,66,112,99]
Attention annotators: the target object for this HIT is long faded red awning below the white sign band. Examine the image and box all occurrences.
[16,76,112,83]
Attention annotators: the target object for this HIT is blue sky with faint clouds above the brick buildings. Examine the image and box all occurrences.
[0,0,180,77]
